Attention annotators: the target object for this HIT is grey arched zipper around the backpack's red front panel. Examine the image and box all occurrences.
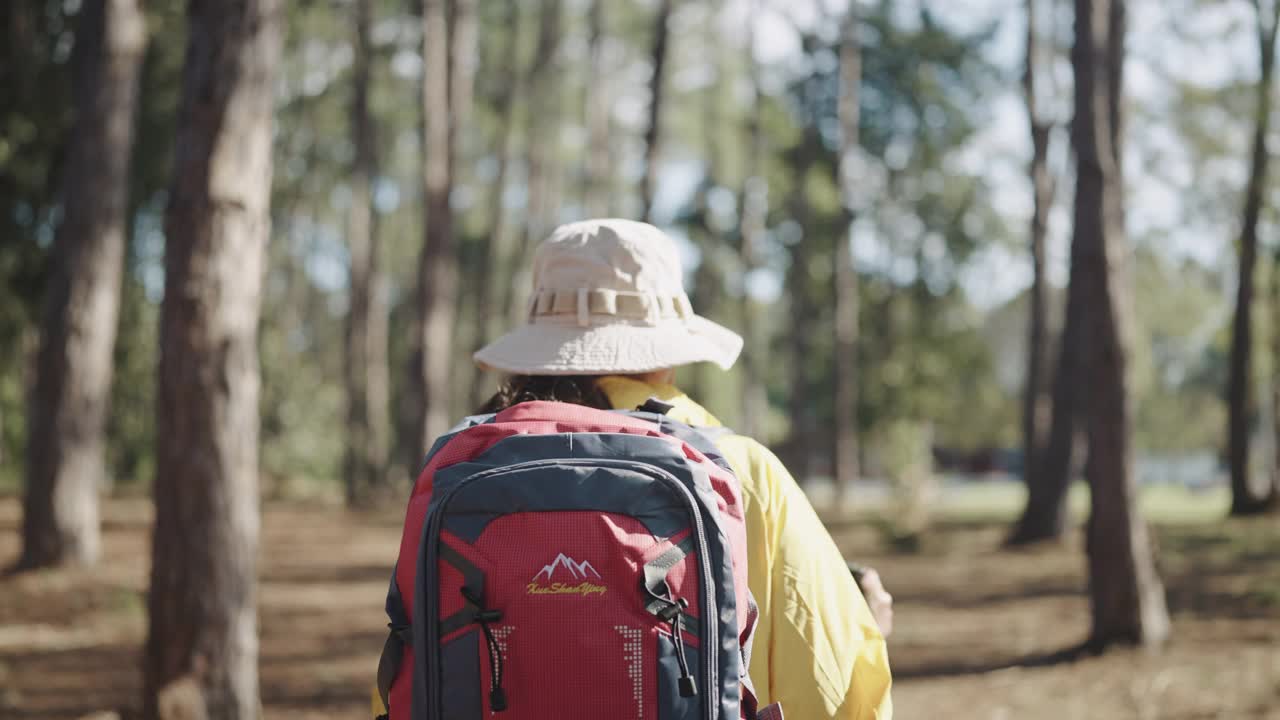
[415,459,719,720]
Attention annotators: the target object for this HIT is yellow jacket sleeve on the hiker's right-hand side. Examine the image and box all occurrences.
[735,438,893,720]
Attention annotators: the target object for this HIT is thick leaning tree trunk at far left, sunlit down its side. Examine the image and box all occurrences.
[18,0,146,568]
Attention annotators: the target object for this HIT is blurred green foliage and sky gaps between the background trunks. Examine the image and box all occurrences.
[0,0,1270,493]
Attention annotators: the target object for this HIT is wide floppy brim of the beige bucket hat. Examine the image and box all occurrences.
[474,315,742,375]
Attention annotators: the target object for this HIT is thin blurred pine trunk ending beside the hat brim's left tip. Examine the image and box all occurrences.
[471,3,521,407]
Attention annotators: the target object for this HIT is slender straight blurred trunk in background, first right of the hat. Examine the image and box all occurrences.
[831,1,863,493]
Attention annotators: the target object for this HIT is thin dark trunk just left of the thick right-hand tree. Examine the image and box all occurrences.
[1009,0,1079,544]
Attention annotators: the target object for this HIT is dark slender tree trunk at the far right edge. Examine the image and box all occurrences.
[1226,0,1280,515]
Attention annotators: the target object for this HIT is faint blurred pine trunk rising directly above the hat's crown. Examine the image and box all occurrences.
[582,0,613,218]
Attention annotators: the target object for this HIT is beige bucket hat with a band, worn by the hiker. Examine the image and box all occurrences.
[475,219,742,375]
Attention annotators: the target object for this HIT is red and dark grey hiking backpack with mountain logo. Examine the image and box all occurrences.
[378,401,781,720]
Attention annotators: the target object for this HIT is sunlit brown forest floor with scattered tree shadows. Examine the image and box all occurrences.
[0,488,1280,720]
